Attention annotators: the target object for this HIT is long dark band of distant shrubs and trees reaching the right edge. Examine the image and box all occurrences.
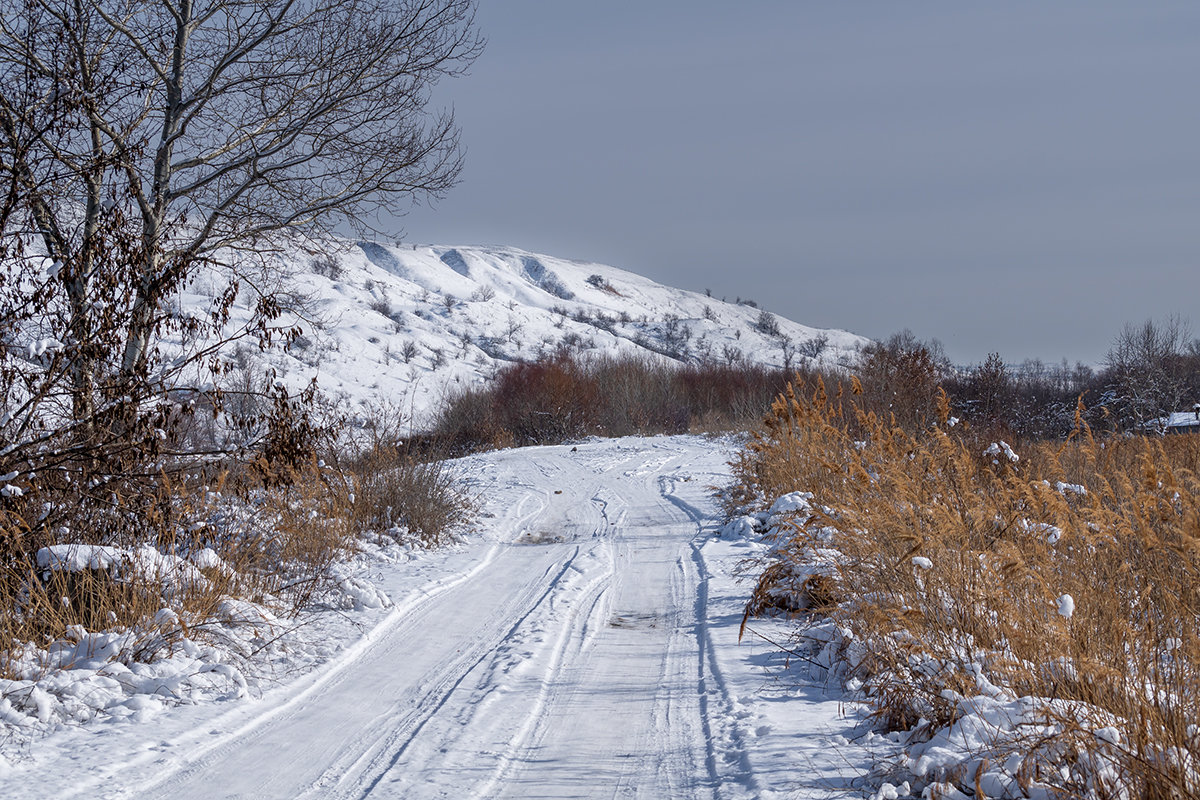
[409,319,1200,453]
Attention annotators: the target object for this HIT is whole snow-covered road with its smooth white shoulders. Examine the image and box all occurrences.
[0,437,876,800]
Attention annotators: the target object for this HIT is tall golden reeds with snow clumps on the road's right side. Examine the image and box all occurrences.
[726,379,1200,799]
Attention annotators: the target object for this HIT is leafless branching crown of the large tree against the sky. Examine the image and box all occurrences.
[0,0,481,388]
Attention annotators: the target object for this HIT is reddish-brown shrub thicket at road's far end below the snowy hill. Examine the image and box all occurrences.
[431,354,788,451]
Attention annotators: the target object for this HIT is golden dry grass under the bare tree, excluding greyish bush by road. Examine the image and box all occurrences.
[0,462,338,675]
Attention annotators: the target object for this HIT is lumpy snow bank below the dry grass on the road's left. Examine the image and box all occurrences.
[0,534,396,742]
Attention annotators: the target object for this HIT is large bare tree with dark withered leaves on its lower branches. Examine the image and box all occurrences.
[0,0,481,555]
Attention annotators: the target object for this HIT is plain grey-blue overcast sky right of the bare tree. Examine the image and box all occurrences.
[395,0,1200,363]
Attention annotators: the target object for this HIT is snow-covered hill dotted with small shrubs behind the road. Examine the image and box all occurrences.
[194,240,866,425]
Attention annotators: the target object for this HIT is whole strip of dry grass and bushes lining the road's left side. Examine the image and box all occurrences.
[0,393,473,680]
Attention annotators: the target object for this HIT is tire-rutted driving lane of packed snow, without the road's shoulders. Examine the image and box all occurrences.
[98,440,757,800]
